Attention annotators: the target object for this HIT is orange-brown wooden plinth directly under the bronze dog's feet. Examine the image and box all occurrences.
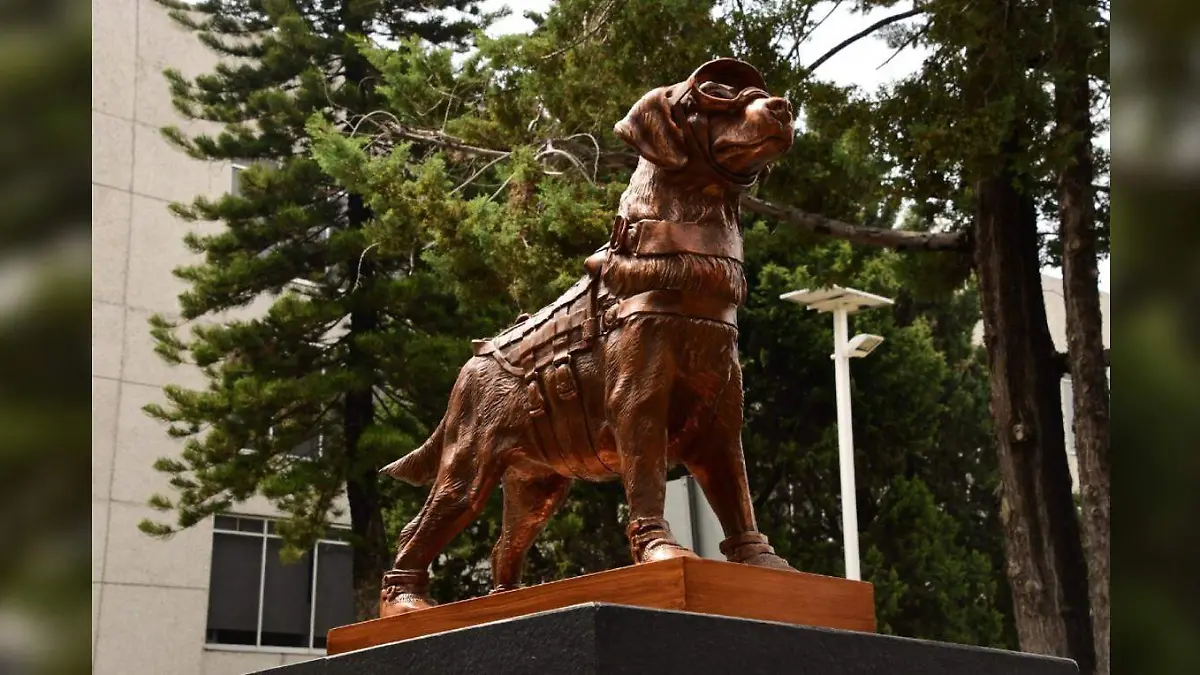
[328,558,875,655]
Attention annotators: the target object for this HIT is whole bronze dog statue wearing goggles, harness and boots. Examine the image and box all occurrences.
[379,59,793,616]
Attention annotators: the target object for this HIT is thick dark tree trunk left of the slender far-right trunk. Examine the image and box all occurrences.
[974,132,1093,675]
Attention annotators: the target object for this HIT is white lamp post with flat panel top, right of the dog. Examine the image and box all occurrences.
[780,286,892,580]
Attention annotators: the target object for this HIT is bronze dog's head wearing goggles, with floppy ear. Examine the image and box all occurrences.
[613,59,793,187]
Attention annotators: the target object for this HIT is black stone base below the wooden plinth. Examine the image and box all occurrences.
[259,603,1079,675]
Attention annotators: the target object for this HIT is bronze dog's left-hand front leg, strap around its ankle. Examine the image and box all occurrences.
[605,316,696,562]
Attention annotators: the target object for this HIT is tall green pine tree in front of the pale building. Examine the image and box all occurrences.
[142,0,488,617]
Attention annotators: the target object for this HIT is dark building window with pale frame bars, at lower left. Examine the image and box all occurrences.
[205,515,354,650]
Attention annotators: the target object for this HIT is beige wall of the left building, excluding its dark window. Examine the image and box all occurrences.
[91,0,333,675]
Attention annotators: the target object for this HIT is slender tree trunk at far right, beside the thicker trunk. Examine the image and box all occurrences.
[1054,0,1110,675]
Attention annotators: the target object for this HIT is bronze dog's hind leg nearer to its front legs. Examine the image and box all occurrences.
[492,468,572,593]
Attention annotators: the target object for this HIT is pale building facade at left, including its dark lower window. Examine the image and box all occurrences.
[91,0,353,675]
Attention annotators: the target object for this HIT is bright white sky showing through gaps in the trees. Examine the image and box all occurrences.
[481,0,1109,292]
